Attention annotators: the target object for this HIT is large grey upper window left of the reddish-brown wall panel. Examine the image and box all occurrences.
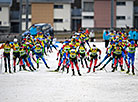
[83,2,94,12]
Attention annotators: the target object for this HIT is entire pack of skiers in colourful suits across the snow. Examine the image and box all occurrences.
[0,30,137,76]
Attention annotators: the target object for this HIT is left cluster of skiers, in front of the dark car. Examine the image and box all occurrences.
[0,32,57,73]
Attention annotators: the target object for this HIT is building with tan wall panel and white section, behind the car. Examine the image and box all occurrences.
[18,0,74,31]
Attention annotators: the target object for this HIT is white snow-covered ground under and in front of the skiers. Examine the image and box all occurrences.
[0,42,138,102]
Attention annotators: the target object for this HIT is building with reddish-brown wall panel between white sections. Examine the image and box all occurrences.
[82,0,135,28]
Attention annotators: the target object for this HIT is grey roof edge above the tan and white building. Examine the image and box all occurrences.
[17,0,74,3]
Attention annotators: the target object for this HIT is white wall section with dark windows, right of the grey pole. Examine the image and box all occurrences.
[116,0,134,28]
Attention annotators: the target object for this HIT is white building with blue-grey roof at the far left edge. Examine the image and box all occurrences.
[0,0,12,33]
